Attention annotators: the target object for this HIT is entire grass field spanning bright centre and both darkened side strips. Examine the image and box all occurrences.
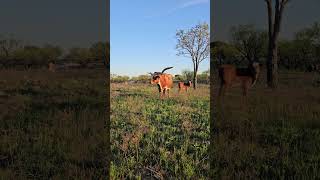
[0,68,320,179]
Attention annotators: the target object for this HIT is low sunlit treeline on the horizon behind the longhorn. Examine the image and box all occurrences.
[110,70,210,84]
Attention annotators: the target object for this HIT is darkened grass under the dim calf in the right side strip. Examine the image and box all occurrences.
[211,72,320,179]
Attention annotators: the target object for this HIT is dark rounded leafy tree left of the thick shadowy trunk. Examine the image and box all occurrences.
[230,25,267,63]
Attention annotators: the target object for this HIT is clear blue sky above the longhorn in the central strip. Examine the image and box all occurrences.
[110,0,210,76]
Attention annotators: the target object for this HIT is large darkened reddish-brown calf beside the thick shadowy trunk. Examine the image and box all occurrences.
[219,62,260,96]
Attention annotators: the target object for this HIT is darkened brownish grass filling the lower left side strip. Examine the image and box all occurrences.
[0,71,107,179]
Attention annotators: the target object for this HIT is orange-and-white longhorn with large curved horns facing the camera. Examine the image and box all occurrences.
[149,67,173,97]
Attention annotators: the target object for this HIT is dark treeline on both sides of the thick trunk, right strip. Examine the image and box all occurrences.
[210,23,320,71]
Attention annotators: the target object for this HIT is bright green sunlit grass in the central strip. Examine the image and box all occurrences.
[110,84,209,179]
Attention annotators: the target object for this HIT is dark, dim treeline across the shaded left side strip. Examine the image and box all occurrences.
[0,35,109,69]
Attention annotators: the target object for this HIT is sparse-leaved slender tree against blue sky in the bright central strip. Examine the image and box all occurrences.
[176,23,210,89]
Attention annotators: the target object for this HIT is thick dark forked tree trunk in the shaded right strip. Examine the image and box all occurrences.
[264,0,290,88]
